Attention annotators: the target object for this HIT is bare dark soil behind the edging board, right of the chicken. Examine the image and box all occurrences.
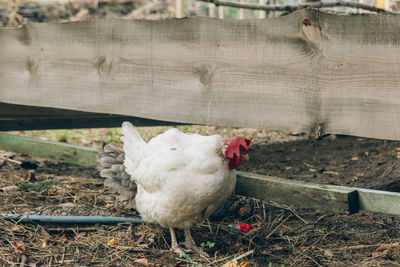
[241,136,400,192]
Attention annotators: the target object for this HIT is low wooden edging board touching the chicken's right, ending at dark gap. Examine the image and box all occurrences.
[236,172,359,214]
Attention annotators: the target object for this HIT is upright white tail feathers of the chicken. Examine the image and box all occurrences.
[121,121,146,178]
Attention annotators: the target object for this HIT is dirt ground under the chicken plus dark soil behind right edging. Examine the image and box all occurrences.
[0,132,400,266]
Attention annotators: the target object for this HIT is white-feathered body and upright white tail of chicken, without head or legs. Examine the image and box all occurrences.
[122,123,236,228]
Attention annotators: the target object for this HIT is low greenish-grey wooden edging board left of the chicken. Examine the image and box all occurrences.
[0,134,97,167]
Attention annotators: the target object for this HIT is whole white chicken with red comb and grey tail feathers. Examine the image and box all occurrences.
[98,122,251,253]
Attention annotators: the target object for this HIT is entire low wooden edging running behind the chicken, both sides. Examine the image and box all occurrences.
[0,133,400,215]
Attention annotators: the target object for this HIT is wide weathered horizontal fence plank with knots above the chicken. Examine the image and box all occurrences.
[0,10,400,140]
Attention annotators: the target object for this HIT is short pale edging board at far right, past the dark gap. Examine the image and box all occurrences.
[357,188,400,215]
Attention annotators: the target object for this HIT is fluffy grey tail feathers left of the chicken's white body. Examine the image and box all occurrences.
[97,144,136,208]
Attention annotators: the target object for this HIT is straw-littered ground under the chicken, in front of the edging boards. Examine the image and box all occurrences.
[0,148,400,266]
